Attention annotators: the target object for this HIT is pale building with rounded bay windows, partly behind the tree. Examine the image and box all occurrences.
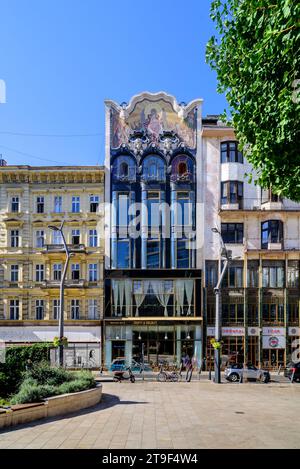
[202,116,300,368]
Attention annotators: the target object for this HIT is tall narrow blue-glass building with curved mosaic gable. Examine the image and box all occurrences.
[104,93,202,367]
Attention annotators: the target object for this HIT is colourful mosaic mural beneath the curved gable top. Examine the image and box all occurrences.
[111,99,197,148]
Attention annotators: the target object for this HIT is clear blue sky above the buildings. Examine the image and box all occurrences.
[0,0,226,165]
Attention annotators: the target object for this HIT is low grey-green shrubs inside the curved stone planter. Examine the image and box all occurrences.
[10,362,96,404]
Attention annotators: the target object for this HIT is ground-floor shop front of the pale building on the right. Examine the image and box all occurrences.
[204,326,300,370]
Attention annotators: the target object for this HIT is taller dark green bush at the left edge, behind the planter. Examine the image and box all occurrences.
[0,343,52,397]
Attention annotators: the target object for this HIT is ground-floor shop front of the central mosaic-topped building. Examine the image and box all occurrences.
[104,321,202,369]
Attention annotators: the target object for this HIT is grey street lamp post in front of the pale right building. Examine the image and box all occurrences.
[211,228,232,383]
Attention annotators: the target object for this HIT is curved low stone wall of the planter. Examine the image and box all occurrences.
[0,384,102,428]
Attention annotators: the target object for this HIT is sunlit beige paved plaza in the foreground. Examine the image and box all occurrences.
[0,381,300,449]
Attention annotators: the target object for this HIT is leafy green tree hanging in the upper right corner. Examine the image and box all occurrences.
[206,0,300,201]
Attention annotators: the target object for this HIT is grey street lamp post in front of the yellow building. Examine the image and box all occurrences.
[48,221,71,366]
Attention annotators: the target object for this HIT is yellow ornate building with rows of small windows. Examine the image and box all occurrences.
[0,165,104,367]
